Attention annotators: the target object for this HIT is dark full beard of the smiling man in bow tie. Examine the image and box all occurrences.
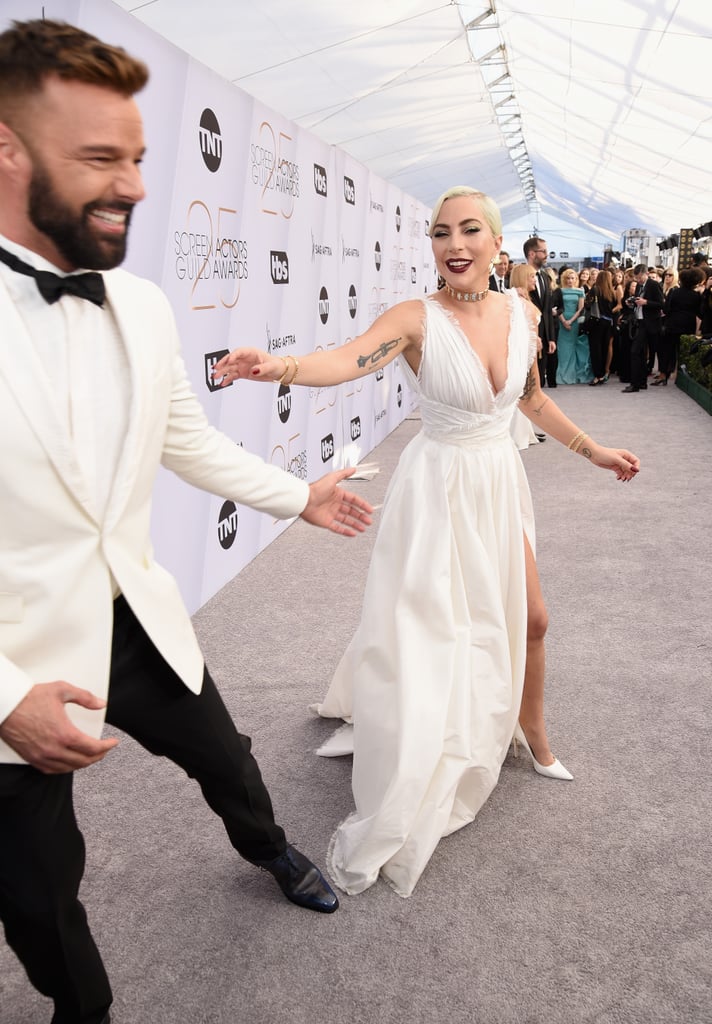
[28,161,133,270]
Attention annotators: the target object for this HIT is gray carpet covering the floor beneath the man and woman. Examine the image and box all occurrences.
[0,381,712,1024]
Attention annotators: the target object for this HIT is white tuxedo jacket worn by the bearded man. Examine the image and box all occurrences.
[0,270,308,763]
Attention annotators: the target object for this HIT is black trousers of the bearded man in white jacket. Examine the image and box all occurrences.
[0,597,286,1024]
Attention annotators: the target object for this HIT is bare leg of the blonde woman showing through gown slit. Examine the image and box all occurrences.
[519,537,555,765]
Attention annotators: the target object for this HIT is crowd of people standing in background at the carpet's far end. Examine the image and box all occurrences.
[490,243,712,394]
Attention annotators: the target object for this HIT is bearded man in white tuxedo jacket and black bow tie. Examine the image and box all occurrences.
[0,20,372,1024]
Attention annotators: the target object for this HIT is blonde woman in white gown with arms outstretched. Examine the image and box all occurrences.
[215,186,638,896]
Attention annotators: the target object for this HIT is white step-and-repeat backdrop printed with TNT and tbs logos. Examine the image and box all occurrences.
[0,0,435,610]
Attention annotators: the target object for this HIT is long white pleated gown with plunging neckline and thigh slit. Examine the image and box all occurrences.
[315,292,536,896]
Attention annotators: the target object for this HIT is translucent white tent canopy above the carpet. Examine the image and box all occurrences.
[96,0,712,255]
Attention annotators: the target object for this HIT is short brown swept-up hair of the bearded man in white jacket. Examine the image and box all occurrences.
[0,18,149,123]
